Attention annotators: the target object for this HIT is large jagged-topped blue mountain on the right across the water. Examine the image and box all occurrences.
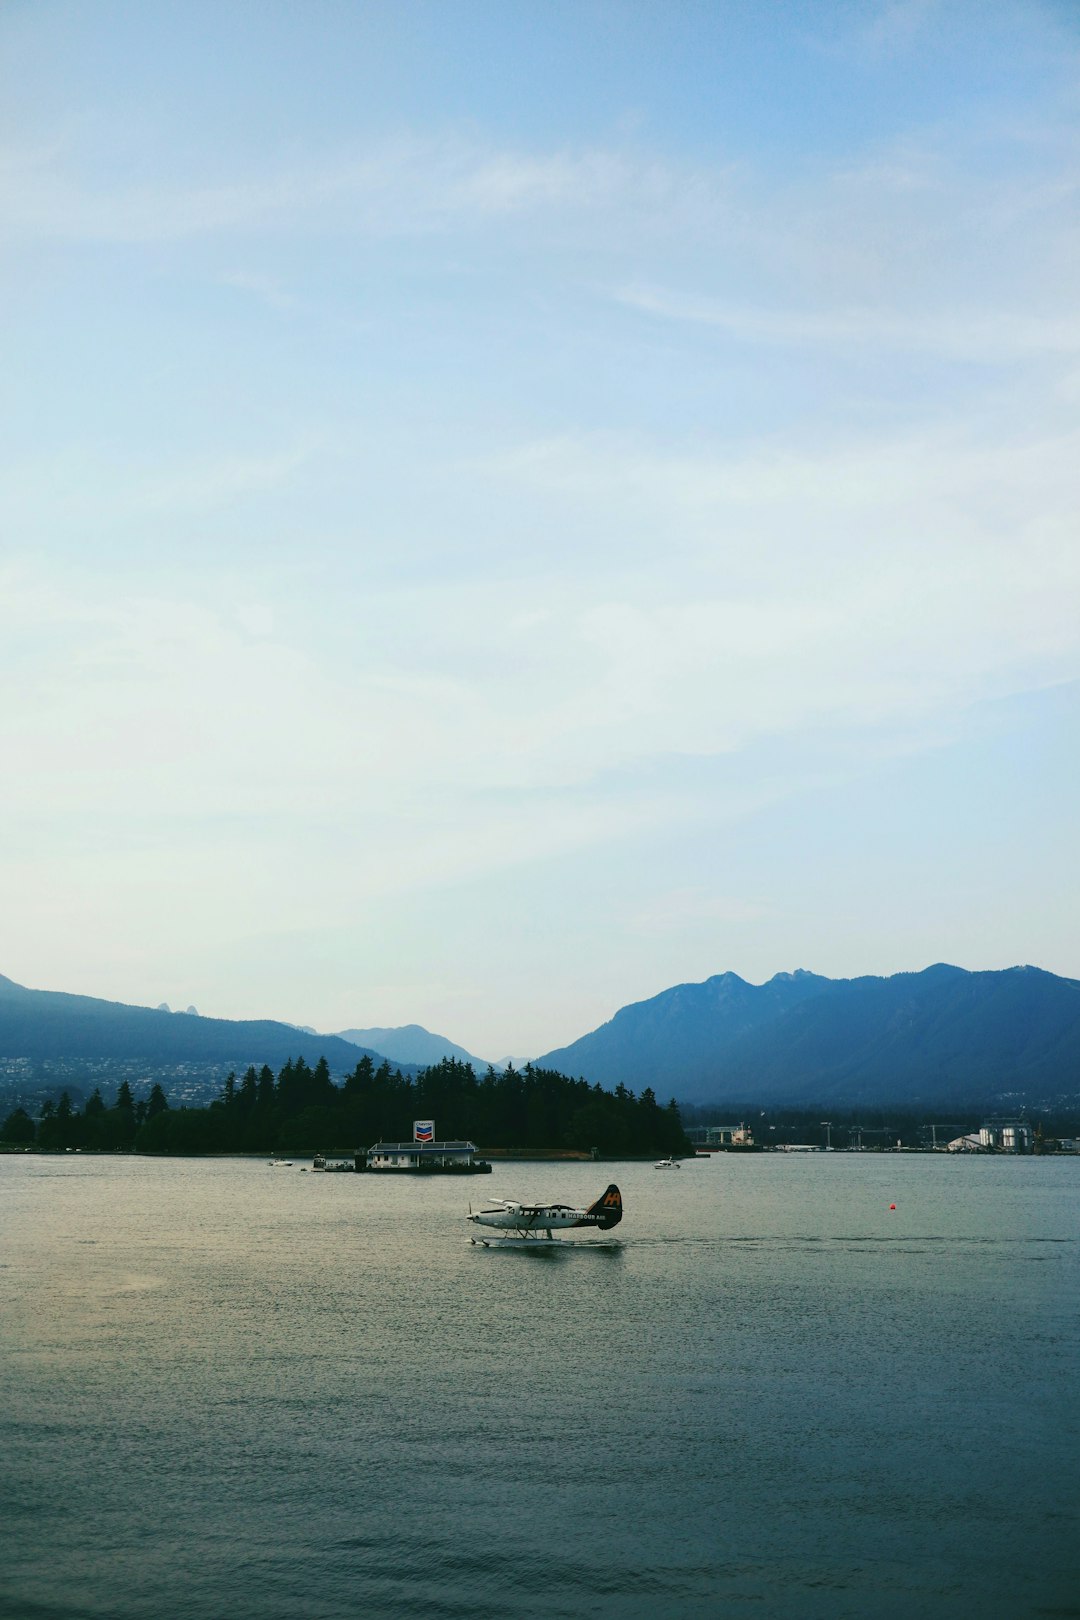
[538,962,1080,1106]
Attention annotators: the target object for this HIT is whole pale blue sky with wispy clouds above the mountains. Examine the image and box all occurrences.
[0,0,1080,1059]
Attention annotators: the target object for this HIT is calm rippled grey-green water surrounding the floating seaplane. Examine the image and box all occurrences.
[0,1153,1080,1620]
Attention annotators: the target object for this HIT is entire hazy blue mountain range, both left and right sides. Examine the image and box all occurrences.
[0,962,1080,1108]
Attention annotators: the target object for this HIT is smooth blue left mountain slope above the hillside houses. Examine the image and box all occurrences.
[0,974,401,1074]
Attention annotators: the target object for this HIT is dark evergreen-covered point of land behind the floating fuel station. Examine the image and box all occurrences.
[0,1055,688,1157]
